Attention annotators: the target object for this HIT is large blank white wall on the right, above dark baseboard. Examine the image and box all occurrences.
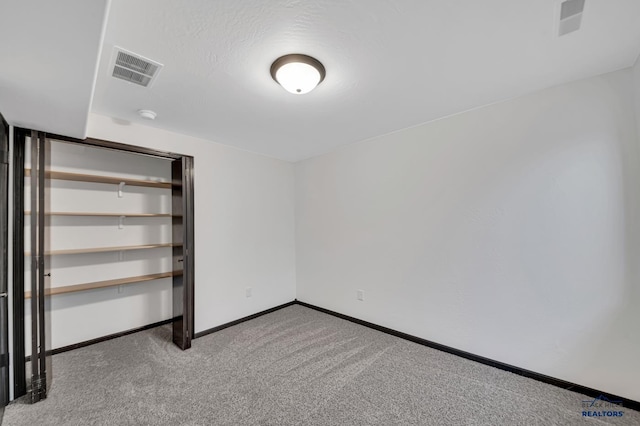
[295,69,640,400]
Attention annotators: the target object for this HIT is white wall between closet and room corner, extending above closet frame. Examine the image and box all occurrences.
[88,114,296,332]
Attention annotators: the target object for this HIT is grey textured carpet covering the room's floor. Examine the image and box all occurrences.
[3,305,640,426]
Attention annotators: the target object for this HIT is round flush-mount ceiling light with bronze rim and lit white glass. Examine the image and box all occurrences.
[271,53,326,95]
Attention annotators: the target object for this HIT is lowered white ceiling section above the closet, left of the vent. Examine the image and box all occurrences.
[0,0,107,138]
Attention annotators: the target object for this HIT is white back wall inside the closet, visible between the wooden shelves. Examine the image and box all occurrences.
[25,141,172,355]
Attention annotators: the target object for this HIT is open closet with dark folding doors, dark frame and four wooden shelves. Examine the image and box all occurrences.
[13,129,194,402]
